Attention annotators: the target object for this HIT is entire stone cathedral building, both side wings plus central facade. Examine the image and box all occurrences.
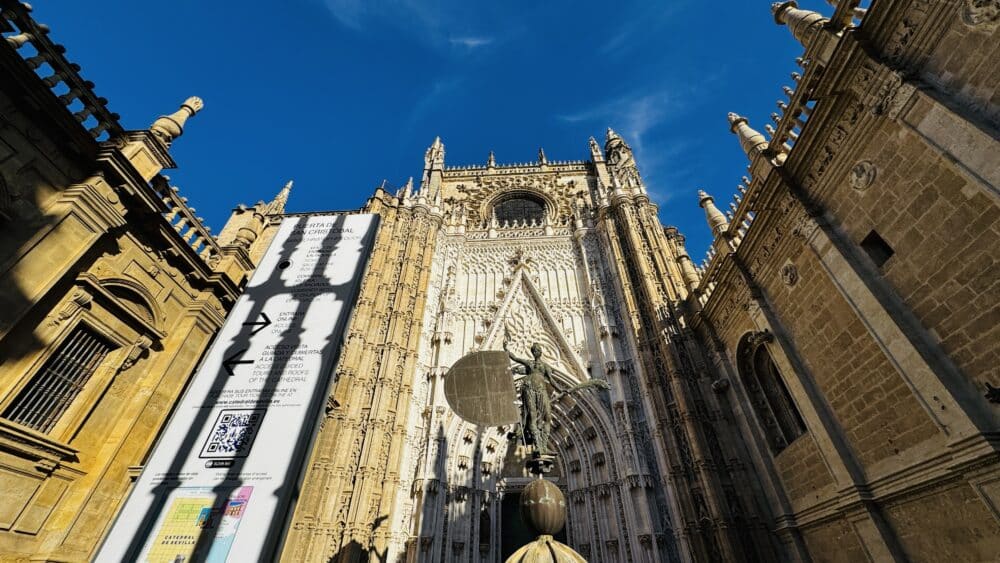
[0,0,1000,563]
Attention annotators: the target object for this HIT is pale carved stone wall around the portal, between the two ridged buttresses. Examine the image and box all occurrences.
[389,170,676,561]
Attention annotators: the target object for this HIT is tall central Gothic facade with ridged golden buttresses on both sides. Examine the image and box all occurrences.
[285,130,760,561]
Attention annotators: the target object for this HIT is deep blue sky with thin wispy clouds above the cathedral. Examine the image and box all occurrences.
[41,0,804,262]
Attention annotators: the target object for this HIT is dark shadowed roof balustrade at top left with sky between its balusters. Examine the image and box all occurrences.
[0,0,124,141]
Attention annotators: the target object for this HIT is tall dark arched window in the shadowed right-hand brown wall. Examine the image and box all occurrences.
[737,332,806,455]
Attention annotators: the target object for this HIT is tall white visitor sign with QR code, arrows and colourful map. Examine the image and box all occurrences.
[97,215,378,563]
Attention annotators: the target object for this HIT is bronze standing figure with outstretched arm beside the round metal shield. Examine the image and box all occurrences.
[503,342,608,456]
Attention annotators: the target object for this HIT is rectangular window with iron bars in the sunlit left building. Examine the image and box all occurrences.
[3,325,111,432]
